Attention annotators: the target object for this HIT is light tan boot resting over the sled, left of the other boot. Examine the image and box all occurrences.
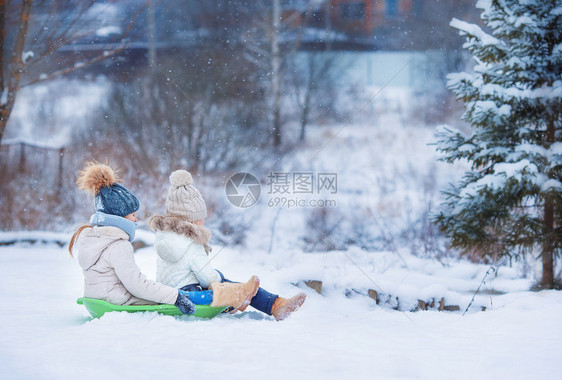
[209,276,260,309]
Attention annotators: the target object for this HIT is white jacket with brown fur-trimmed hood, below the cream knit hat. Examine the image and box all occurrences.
[148,215,221,289]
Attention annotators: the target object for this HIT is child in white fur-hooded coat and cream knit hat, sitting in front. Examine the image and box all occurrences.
[148,170,306,320]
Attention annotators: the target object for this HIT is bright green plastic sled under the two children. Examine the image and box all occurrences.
[76,297,225,318]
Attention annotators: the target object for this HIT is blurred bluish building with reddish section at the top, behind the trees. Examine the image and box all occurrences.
[283,0,480,50]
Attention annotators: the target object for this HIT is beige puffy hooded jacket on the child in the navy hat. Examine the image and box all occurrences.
[78,226,178,305]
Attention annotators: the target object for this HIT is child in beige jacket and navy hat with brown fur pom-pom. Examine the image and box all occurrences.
[69,163,257,314]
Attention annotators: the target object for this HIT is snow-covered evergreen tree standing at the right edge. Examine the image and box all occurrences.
[436,0,562,289]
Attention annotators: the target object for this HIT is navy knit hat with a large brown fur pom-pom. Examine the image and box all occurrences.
[77,162,140,217]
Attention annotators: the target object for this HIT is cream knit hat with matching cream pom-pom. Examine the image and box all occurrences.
[166,170,207,222]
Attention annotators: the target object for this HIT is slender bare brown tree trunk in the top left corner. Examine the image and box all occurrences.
[0,0,33,144]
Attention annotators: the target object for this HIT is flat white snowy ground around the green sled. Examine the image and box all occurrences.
[0,244,562,380]
